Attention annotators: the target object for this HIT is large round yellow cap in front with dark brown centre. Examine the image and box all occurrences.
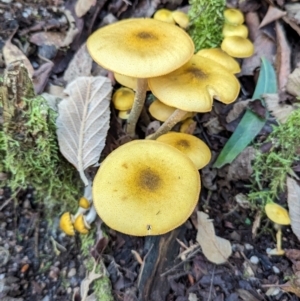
[93,140,200,236]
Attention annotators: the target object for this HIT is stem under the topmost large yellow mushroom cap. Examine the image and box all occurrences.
[126,78,148,137]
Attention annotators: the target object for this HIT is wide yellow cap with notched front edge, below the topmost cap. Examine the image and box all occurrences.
[148,55,240,112]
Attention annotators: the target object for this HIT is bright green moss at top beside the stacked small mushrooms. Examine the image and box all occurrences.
[188,0,226,51]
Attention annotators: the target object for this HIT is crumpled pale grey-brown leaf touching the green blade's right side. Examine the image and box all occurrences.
[262,93,294,123]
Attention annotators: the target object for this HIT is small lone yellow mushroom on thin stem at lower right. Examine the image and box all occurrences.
[265,203,291,255]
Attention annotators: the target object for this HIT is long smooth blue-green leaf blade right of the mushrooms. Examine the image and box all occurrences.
[213,58,277,168]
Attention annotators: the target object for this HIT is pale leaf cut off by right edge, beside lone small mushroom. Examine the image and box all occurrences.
[286,177,300,240]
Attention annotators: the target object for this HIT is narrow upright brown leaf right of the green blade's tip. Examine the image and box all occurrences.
[275,21,291,91]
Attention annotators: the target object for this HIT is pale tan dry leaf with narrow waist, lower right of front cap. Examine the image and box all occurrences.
[197,211,232,264]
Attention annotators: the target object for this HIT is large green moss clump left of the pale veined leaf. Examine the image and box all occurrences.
[0,71,82,217]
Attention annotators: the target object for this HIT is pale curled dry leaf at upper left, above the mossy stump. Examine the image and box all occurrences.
[2,40,34,78]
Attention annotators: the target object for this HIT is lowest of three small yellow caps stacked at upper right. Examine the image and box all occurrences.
[221,36,254,58]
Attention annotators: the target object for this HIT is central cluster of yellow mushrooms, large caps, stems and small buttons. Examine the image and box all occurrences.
[60,7,260,236]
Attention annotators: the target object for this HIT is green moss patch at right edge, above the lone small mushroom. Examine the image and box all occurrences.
[248,109,300,206]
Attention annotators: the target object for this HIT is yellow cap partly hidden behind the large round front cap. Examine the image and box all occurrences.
[156,132,211,169]
